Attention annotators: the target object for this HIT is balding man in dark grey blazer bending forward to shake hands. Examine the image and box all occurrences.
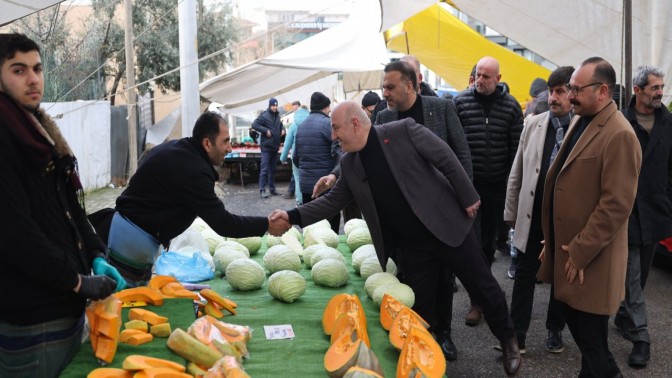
[270,101,521,375]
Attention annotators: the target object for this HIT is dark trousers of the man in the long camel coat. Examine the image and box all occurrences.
[564,305,621,378]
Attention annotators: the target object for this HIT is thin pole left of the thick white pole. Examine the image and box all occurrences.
[124,0,138,177]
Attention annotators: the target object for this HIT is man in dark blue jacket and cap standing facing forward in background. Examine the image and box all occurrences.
[252,98,285,198]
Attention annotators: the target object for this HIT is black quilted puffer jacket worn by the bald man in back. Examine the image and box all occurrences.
[454,86,523,182]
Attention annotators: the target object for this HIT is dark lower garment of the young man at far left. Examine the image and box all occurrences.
[0,315,84,378]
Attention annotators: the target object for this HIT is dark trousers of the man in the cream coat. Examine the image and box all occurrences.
[511,244,565,347]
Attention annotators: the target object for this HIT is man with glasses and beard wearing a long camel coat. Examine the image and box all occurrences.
[538,57,642,377]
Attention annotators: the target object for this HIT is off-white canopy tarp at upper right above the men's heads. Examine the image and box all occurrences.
[452,0,672,103]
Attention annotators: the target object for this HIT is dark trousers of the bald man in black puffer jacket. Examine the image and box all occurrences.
[474,180,507,266]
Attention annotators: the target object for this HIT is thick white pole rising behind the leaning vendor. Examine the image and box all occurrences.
[177,0,200,137]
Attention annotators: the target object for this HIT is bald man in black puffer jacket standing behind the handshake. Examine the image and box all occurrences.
[454,57,523,326]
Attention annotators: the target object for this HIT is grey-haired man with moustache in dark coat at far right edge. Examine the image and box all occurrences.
[614,66,672,367]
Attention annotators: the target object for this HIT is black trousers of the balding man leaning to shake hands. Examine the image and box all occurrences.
[397,232,515,342]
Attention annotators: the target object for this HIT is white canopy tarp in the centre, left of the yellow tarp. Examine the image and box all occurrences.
[200,0,436,113]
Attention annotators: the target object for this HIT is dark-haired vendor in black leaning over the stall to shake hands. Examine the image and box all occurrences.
[89,112,290,286]
